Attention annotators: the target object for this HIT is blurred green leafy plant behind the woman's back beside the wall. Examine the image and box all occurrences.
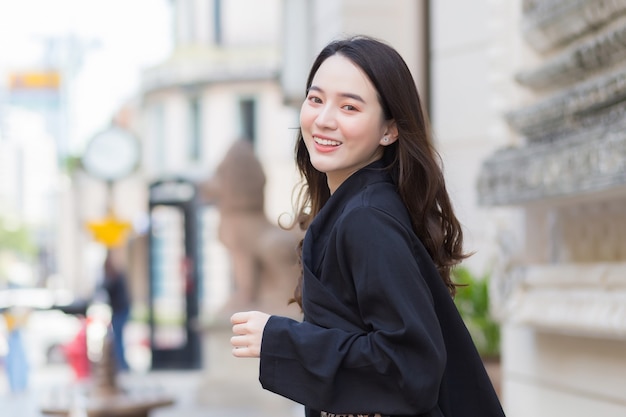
[452,266,500,358]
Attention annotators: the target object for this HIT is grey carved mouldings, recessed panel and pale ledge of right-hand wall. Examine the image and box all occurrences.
[477,0,626,339]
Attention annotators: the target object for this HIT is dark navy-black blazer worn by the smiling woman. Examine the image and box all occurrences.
[259,162,504,417]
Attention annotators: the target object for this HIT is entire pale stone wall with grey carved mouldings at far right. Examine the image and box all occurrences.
[477,0,626,417]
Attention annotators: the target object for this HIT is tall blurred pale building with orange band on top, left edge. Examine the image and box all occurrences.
[0,67,62,287]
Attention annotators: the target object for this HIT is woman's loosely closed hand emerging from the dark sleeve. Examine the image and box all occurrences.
[230,311,270,358]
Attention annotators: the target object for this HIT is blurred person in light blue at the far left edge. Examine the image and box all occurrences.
[2,307,30,393]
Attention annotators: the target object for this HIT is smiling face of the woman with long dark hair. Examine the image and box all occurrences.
[300,54,397,193]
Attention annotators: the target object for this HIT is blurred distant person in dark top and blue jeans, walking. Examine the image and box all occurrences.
[102,250,130,371]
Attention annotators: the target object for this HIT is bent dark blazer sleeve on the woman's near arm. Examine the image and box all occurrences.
[260,207,446,415]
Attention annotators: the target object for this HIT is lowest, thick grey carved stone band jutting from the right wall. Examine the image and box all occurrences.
[477,125,626,205]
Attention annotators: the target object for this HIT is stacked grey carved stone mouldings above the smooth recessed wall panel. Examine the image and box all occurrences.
[478,0,626,205]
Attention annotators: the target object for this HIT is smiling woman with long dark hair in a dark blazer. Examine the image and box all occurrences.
[231,36,504,417]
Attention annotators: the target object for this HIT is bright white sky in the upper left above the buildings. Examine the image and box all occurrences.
[0,0,172,153]
